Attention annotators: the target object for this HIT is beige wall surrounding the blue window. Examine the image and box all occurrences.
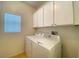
[0,2,35,57]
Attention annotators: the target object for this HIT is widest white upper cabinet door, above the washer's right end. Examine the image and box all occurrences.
[54,1,73,25]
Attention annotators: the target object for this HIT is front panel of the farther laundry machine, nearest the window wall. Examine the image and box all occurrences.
[25,38,32,57]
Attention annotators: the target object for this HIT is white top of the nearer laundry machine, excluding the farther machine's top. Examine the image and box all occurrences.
[38,36,60,50]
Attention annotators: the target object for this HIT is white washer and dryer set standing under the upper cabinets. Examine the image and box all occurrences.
[25,35,61,58]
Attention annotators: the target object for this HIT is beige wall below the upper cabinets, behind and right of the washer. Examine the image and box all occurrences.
[37,26,79,57]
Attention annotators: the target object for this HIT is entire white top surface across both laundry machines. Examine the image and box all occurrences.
[26,36,60,50]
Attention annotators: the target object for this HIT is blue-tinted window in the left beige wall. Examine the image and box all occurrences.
[4,13,21,32]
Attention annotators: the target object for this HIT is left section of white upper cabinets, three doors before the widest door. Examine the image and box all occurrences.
[33,2,53,27]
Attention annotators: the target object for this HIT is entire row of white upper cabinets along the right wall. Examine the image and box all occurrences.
[33,1,75,27]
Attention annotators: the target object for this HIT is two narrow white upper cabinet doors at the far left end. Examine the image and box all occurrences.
[33,8,43,27]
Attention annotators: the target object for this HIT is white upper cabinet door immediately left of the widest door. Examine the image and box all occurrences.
[43,2,53,26]
